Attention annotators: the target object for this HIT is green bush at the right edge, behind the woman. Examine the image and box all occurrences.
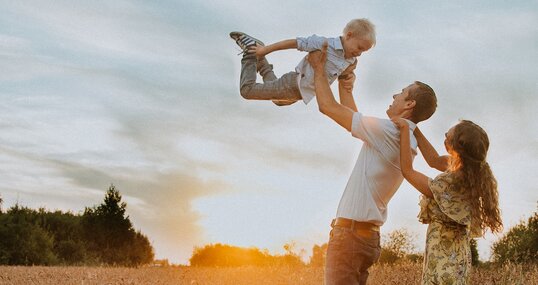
[492,205,538,263]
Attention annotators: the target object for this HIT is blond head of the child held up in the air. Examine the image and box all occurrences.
[342,19,375,58]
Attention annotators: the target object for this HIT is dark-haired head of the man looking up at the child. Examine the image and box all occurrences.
[387,81,437,124]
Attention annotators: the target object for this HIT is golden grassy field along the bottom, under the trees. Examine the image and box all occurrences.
[0,263,538,285]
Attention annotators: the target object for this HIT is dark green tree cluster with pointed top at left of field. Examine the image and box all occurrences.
[0,185,154,266]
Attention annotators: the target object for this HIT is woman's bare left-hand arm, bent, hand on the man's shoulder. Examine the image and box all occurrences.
[392,118,433,198]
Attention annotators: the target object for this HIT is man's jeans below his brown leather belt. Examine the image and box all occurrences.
[325,226,381,285]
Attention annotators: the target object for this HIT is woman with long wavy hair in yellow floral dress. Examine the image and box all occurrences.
[393,119,502,284]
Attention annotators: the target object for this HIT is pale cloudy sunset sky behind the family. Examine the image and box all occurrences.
[0,0,538,264]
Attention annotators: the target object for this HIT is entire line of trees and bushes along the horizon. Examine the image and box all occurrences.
[0,185,538,267]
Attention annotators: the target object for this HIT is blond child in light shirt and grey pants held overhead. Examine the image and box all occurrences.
[230,19,375,106]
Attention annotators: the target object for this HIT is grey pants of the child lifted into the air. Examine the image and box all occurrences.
[239,54,302,105]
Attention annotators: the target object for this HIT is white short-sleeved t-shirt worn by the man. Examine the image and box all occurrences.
[336,112,417,226]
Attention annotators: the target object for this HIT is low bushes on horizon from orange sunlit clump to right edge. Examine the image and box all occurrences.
[189,205,538,267]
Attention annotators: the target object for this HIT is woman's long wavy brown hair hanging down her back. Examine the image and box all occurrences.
[447,120,503,233]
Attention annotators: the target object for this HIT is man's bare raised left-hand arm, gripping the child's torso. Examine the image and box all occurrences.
[308,42,354,132]
